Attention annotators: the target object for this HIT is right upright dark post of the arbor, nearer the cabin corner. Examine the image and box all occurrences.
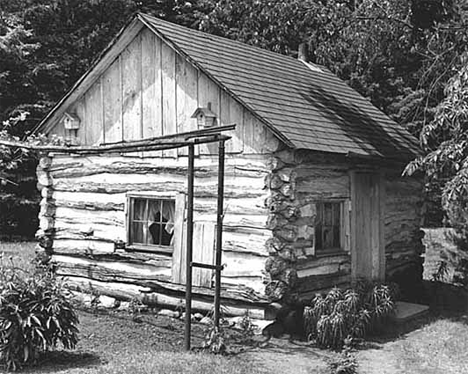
[214,140,225,327]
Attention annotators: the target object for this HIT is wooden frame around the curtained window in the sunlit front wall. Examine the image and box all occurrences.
[125,191,177,255]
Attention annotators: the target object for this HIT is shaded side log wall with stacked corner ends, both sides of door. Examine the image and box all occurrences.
[266,151,422,299]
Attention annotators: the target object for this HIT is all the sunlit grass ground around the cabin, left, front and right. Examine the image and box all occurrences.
[0,243,468,374]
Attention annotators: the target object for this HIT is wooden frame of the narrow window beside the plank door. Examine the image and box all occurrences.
[314,199,351,257]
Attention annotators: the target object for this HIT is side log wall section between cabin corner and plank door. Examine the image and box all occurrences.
[266,151,350,300]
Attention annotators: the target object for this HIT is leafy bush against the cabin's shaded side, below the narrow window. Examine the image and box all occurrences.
[304,282,395,349]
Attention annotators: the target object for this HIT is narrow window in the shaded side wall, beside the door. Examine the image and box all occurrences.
[315,201,349,254]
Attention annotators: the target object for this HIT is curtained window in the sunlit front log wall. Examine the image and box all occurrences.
[128,196,175,252]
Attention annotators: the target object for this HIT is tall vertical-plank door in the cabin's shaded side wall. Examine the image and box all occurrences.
[351,172,385,280]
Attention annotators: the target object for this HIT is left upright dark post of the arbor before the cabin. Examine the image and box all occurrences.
[185,144,195,351]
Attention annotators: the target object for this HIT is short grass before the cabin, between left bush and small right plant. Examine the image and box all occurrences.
[12,311,334,374]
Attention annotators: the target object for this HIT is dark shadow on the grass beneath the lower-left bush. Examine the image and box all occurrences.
[22,351,103,373]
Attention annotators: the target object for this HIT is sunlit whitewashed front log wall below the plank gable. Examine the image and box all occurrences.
[37,155,271,309]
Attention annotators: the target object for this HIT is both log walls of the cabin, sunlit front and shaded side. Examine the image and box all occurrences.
[38,150,422,312]
